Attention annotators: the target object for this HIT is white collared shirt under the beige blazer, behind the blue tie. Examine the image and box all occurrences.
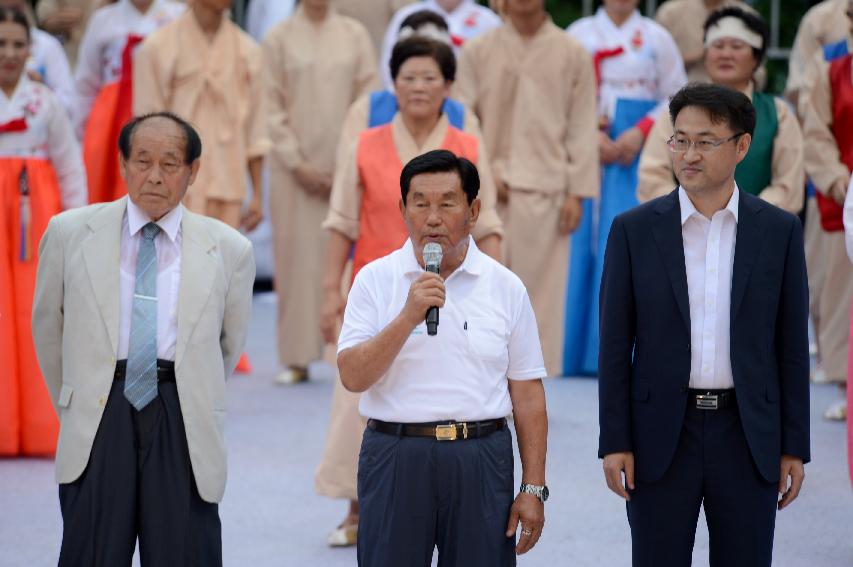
[116,198,183,360]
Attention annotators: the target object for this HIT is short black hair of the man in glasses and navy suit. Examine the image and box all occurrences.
[669,83,755,136]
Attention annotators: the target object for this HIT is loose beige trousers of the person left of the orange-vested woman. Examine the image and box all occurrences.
[270,165,329,367]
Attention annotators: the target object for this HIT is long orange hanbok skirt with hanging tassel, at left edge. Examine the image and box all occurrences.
[0,157,62,456]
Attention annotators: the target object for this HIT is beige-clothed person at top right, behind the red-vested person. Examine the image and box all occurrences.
[785,0,850,105]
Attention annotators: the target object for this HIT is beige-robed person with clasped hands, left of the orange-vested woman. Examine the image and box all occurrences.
[263,0,378,383]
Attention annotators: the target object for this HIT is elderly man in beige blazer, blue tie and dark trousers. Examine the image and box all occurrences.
[33,113,255,566]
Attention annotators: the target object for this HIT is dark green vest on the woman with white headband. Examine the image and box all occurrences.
[735,92,779,195]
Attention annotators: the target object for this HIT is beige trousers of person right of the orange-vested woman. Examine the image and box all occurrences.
[503,188,571,376]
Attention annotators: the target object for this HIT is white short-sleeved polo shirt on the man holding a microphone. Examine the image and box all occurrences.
[338,237,546,423]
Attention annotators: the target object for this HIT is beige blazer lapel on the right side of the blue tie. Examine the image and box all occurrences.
[175,211,216,366]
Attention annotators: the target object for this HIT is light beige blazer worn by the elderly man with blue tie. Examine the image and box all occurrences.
[33,197,255,502]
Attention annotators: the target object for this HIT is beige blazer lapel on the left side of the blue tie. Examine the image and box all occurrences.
[83,197,127,353]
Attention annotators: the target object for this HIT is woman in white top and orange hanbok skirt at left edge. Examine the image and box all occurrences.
[0,8,86,456]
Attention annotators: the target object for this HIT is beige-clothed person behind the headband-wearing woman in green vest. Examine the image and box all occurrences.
[655,0,752,83]
